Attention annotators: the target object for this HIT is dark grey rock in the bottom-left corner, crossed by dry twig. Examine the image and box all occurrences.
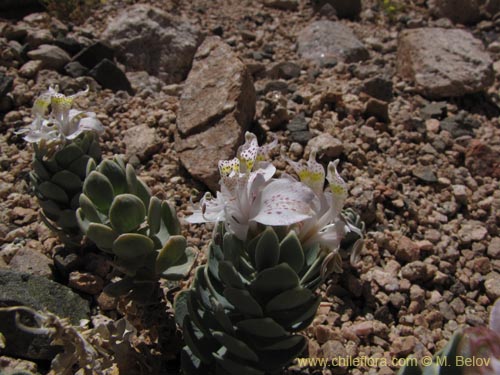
[0,269,90,360]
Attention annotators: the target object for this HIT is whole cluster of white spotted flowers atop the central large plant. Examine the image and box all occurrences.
[186,132,361,262]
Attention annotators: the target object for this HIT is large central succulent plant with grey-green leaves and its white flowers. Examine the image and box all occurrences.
[175,133,361,374]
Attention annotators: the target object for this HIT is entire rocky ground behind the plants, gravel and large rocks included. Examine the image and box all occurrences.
[0,0,500,375]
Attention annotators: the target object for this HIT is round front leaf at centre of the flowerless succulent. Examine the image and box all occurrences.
[109,194,146,233]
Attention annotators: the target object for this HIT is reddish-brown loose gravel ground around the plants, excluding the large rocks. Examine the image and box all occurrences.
[0,0,500,375]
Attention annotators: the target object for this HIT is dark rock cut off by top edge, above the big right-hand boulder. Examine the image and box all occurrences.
[427,0,481,25]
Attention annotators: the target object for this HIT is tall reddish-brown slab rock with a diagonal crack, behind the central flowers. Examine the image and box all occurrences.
[175,37,256,191]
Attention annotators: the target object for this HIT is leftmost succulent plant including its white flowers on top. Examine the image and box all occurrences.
[17,87,104,246]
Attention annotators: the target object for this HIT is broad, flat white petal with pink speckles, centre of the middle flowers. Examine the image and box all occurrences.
[251,178,315,225]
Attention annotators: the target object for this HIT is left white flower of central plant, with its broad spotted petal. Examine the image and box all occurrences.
[186,132,315,240]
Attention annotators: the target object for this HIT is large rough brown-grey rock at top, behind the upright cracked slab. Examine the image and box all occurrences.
[102,4,201,83]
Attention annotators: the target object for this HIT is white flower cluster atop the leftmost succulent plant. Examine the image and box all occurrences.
[18,87,104,143]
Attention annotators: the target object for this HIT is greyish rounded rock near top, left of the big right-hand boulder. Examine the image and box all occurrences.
[297,20,369,65]
